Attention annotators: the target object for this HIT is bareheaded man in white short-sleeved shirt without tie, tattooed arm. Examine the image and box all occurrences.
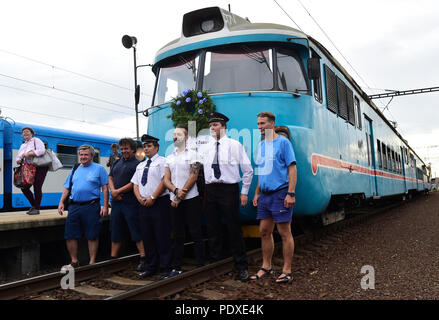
[164,126,205,276]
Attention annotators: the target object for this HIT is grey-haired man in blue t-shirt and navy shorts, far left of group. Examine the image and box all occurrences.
[58,145,109,267]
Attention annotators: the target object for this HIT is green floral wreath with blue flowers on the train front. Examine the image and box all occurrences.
[167,89,215,134]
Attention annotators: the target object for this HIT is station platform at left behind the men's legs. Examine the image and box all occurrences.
[0,209,110,279]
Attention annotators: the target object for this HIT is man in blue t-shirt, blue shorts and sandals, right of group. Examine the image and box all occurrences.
[250,112,297,283]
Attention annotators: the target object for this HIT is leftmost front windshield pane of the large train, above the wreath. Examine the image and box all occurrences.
[154,54,199,105]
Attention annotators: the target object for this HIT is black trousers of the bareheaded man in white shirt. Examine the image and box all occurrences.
[171,196,205,270]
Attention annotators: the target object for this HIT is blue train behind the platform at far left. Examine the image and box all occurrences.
[0,119,119,211]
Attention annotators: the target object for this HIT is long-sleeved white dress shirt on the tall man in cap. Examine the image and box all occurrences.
[198,136,253,195]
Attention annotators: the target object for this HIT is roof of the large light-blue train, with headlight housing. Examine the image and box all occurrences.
[153,7,425,165]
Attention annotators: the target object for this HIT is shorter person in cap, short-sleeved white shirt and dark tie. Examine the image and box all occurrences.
[131,134,172,278]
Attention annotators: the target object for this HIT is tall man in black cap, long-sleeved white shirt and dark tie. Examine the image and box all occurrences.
[200,112,253,281]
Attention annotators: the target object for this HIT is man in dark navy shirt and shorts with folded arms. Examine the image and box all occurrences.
[108,138,145,271]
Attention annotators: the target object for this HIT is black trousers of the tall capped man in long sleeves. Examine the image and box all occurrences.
[206,183,248,270]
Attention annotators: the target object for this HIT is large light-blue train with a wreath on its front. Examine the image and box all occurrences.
[147,7,430,223]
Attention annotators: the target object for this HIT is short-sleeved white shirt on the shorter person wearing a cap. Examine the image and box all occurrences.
[131,154,169,198]
